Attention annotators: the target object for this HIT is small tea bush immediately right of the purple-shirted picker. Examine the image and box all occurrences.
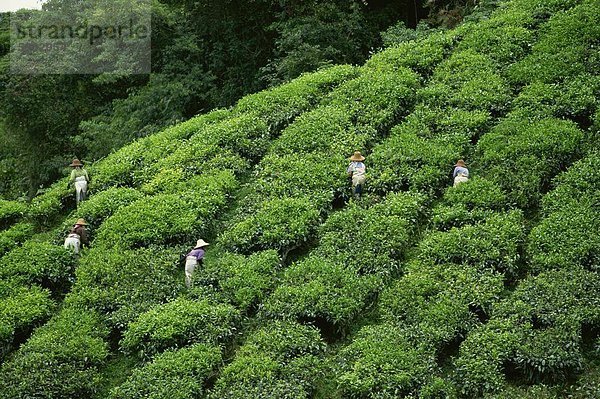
[195,250,280,310]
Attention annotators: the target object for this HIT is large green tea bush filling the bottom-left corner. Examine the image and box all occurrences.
[0,309,108,399]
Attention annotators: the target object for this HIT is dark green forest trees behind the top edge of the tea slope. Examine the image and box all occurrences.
[0,0,482,199]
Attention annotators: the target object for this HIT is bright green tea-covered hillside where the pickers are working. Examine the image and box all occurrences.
[0,0,600,399]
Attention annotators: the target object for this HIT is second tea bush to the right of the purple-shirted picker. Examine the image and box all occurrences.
[262,256,381,327]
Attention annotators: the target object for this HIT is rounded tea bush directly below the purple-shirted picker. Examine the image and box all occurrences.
[121,297,240,358]
